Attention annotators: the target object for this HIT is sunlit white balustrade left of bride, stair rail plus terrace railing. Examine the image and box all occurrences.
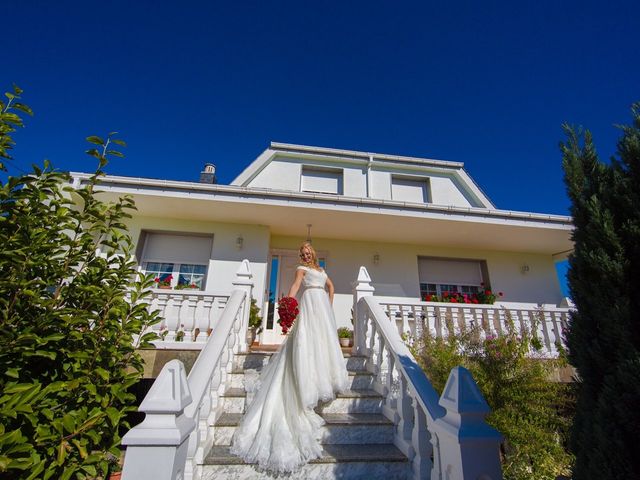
[122,260,253,480]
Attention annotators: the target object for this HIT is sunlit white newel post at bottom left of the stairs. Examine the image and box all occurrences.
[122,360,196,480]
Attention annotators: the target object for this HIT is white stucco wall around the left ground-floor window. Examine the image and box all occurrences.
[129,217,269,305]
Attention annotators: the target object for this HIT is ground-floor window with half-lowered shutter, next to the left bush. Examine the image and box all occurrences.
[142,233,213,290]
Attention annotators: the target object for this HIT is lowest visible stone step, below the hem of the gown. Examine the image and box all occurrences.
[203,444,412,480]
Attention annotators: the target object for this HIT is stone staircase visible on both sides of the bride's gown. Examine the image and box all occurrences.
[202,353,413,480]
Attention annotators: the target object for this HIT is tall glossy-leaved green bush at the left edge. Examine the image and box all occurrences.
[0,89,157,480]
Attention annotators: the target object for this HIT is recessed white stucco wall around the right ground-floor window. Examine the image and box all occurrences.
[271,236,562,326]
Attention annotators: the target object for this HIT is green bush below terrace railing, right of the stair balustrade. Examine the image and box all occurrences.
[412,319,572,480]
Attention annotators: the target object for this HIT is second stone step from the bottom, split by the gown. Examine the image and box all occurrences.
[213,413,394,445]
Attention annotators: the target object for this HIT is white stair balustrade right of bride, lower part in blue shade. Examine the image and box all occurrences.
[355,295,502,480]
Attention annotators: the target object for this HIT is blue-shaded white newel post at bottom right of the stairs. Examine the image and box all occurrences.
[432,367,502,480]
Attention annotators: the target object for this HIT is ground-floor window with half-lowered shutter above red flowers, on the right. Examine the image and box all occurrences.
[418,258,486,300]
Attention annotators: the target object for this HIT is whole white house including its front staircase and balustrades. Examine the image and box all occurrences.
[111,143,572,480]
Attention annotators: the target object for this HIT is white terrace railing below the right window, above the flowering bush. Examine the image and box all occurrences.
[379,297,570,358]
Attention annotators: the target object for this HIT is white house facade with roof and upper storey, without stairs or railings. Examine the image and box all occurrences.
[72,143,572,344]
